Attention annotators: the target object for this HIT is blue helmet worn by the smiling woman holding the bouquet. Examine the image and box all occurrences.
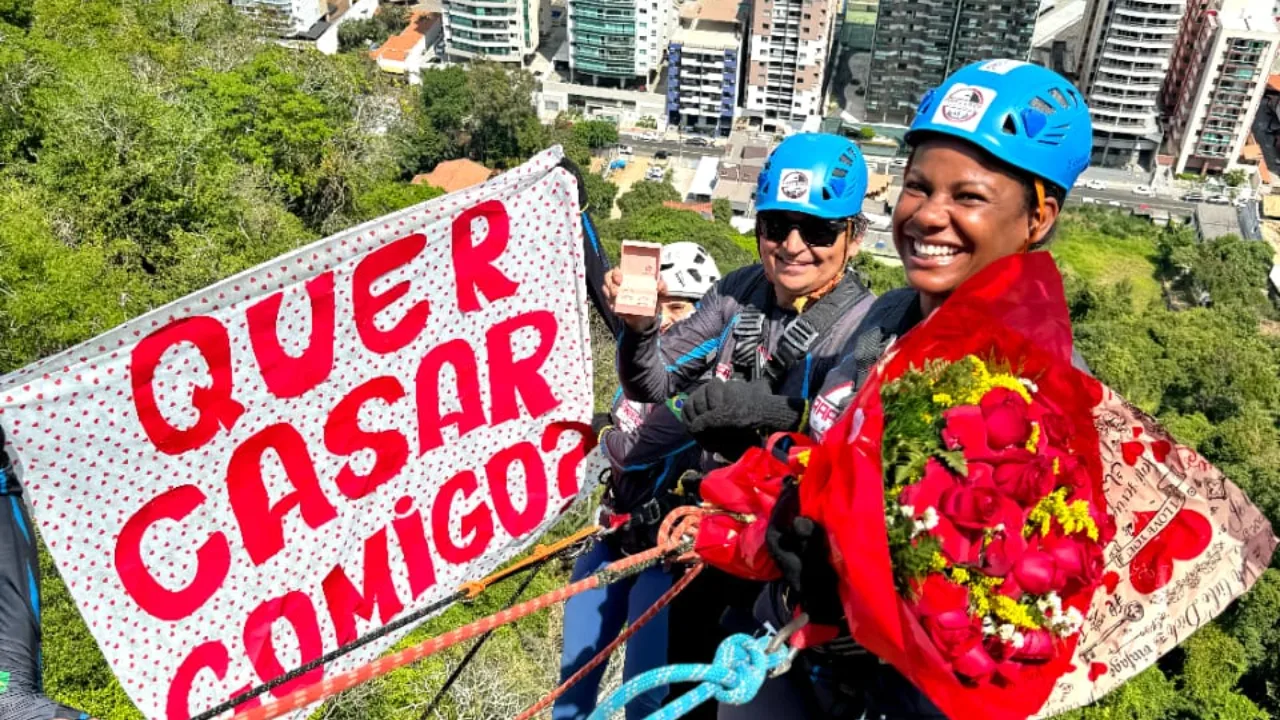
[906,60,1093,190]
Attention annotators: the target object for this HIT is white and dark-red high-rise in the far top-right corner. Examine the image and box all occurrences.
[1164,0,1280,173]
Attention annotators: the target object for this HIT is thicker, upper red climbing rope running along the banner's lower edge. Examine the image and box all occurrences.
[227,507,703,720]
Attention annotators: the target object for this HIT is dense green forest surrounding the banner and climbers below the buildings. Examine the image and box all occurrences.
[0,0,1280,720]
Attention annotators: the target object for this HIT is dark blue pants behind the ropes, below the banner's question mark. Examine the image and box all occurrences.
[552,541,672,720]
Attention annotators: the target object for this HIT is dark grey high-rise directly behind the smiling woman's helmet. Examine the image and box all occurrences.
[867,0,1041,120]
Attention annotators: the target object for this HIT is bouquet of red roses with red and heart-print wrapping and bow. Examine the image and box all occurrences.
[698,254,1276,719]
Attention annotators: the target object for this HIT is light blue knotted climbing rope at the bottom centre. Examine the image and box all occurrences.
[588,633,791,720]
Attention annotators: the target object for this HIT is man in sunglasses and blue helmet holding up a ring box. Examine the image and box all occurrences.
[604,133,873,717]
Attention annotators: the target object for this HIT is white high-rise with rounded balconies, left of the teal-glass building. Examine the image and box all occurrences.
[444,0,541,63]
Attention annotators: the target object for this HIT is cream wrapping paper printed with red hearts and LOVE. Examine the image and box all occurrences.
[1039,388,1277,717]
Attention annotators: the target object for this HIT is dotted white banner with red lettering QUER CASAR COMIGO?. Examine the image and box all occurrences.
[0,149,591,720]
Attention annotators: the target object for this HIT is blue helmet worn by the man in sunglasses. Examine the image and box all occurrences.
[755,132,867,215]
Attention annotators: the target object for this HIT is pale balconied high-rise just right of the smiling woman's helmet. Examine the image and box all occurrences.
[1079,0,1185,168]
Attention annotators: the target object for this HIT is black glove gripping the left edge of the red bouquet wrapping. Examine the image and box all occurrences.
[764,482,845,625]
